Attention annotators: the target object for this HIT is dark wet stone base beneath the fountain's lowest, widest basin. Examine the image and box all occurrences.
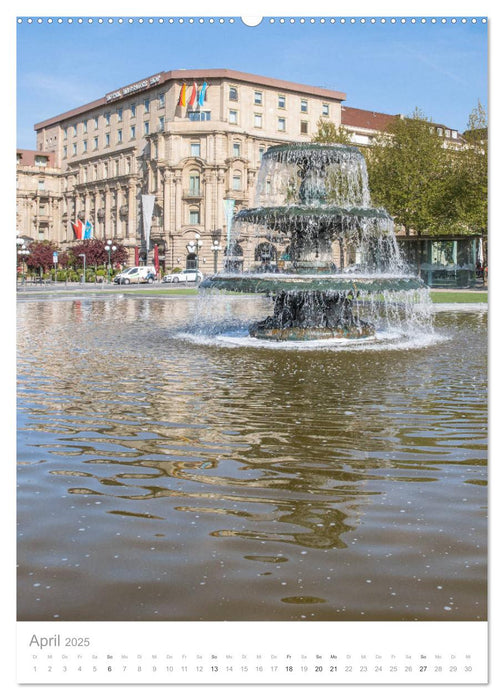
[249,291,375,341]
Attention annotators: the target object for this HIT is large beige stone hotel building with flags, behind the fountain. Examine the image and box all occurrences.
[17,69,461,274]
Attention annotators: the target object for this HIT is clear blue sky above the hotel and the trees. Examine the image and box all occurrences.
[16,15,488,148]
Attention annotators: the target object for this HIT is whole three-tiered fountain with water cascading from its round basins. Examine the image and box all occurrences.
[201,143,425,341]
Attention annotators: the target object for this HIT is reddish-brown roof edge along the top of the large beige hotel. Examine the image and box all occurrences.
[34,68,346,131]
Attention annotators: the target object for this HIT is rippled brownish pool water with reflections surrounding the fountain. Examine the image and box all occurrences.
[18,295,487,620]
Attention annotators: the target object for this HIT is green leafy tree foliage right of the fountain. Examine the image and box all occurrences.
[366,105,487,235]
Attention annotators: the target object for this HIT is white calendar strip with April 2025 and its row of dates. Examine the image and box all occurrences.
[18,622,487,684]
